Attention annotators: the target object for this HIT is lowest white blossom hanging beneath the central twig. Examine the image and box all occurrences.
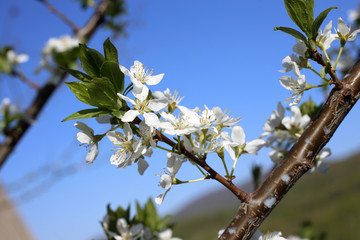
[155,152,185,205]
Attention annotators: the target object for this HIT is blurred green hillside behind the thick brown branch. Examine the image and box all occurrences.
[174,155,360,240]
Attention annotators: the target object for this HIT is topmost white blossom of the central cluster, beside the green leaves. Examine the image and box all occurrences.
[120,61,164,99]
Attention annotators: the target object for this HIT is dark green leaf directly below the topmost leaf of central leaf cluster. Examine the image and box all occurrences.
[100,61,124,93]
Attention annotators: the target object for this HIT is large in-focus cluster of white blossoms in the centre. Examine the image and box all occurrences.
[75,61,265,204]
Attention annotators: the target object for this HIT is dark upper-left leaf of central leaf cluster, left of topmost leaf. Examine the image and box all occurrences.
[80,44,105,77]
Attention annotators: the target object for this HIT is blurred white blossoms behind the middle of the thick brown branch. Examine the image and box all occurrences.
[260,102,331,173]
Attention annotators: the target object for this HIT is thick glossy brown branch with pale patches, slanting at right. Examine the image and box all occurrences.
[219,59,360,240]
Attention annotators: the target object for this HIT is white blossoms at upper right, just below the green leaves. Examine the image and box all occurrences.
[279,18,360,106]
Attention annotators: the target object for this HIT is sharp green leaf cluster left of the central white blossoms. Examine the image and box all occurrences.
[63,38,126,121]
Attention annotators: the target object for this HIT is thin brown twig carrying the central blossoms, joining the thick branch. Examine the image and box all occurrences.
[155,130,249,202]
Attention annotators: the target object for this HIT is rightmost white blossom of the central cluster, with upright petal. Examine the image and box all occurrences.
[221,125,265,160]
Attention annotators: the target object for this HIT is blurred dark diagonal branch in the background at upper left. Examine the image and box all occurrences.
[0,0,110,168]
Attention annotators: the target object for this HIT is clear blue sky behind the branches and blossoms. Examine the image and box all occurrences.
[0,0,360,240]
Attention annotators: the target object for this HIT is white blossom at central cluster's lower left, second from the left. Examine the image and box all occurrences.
[106,123,148,174]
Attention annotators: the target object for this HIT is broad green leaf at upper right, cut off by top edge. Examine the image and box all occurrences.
[284,0,314,37]
